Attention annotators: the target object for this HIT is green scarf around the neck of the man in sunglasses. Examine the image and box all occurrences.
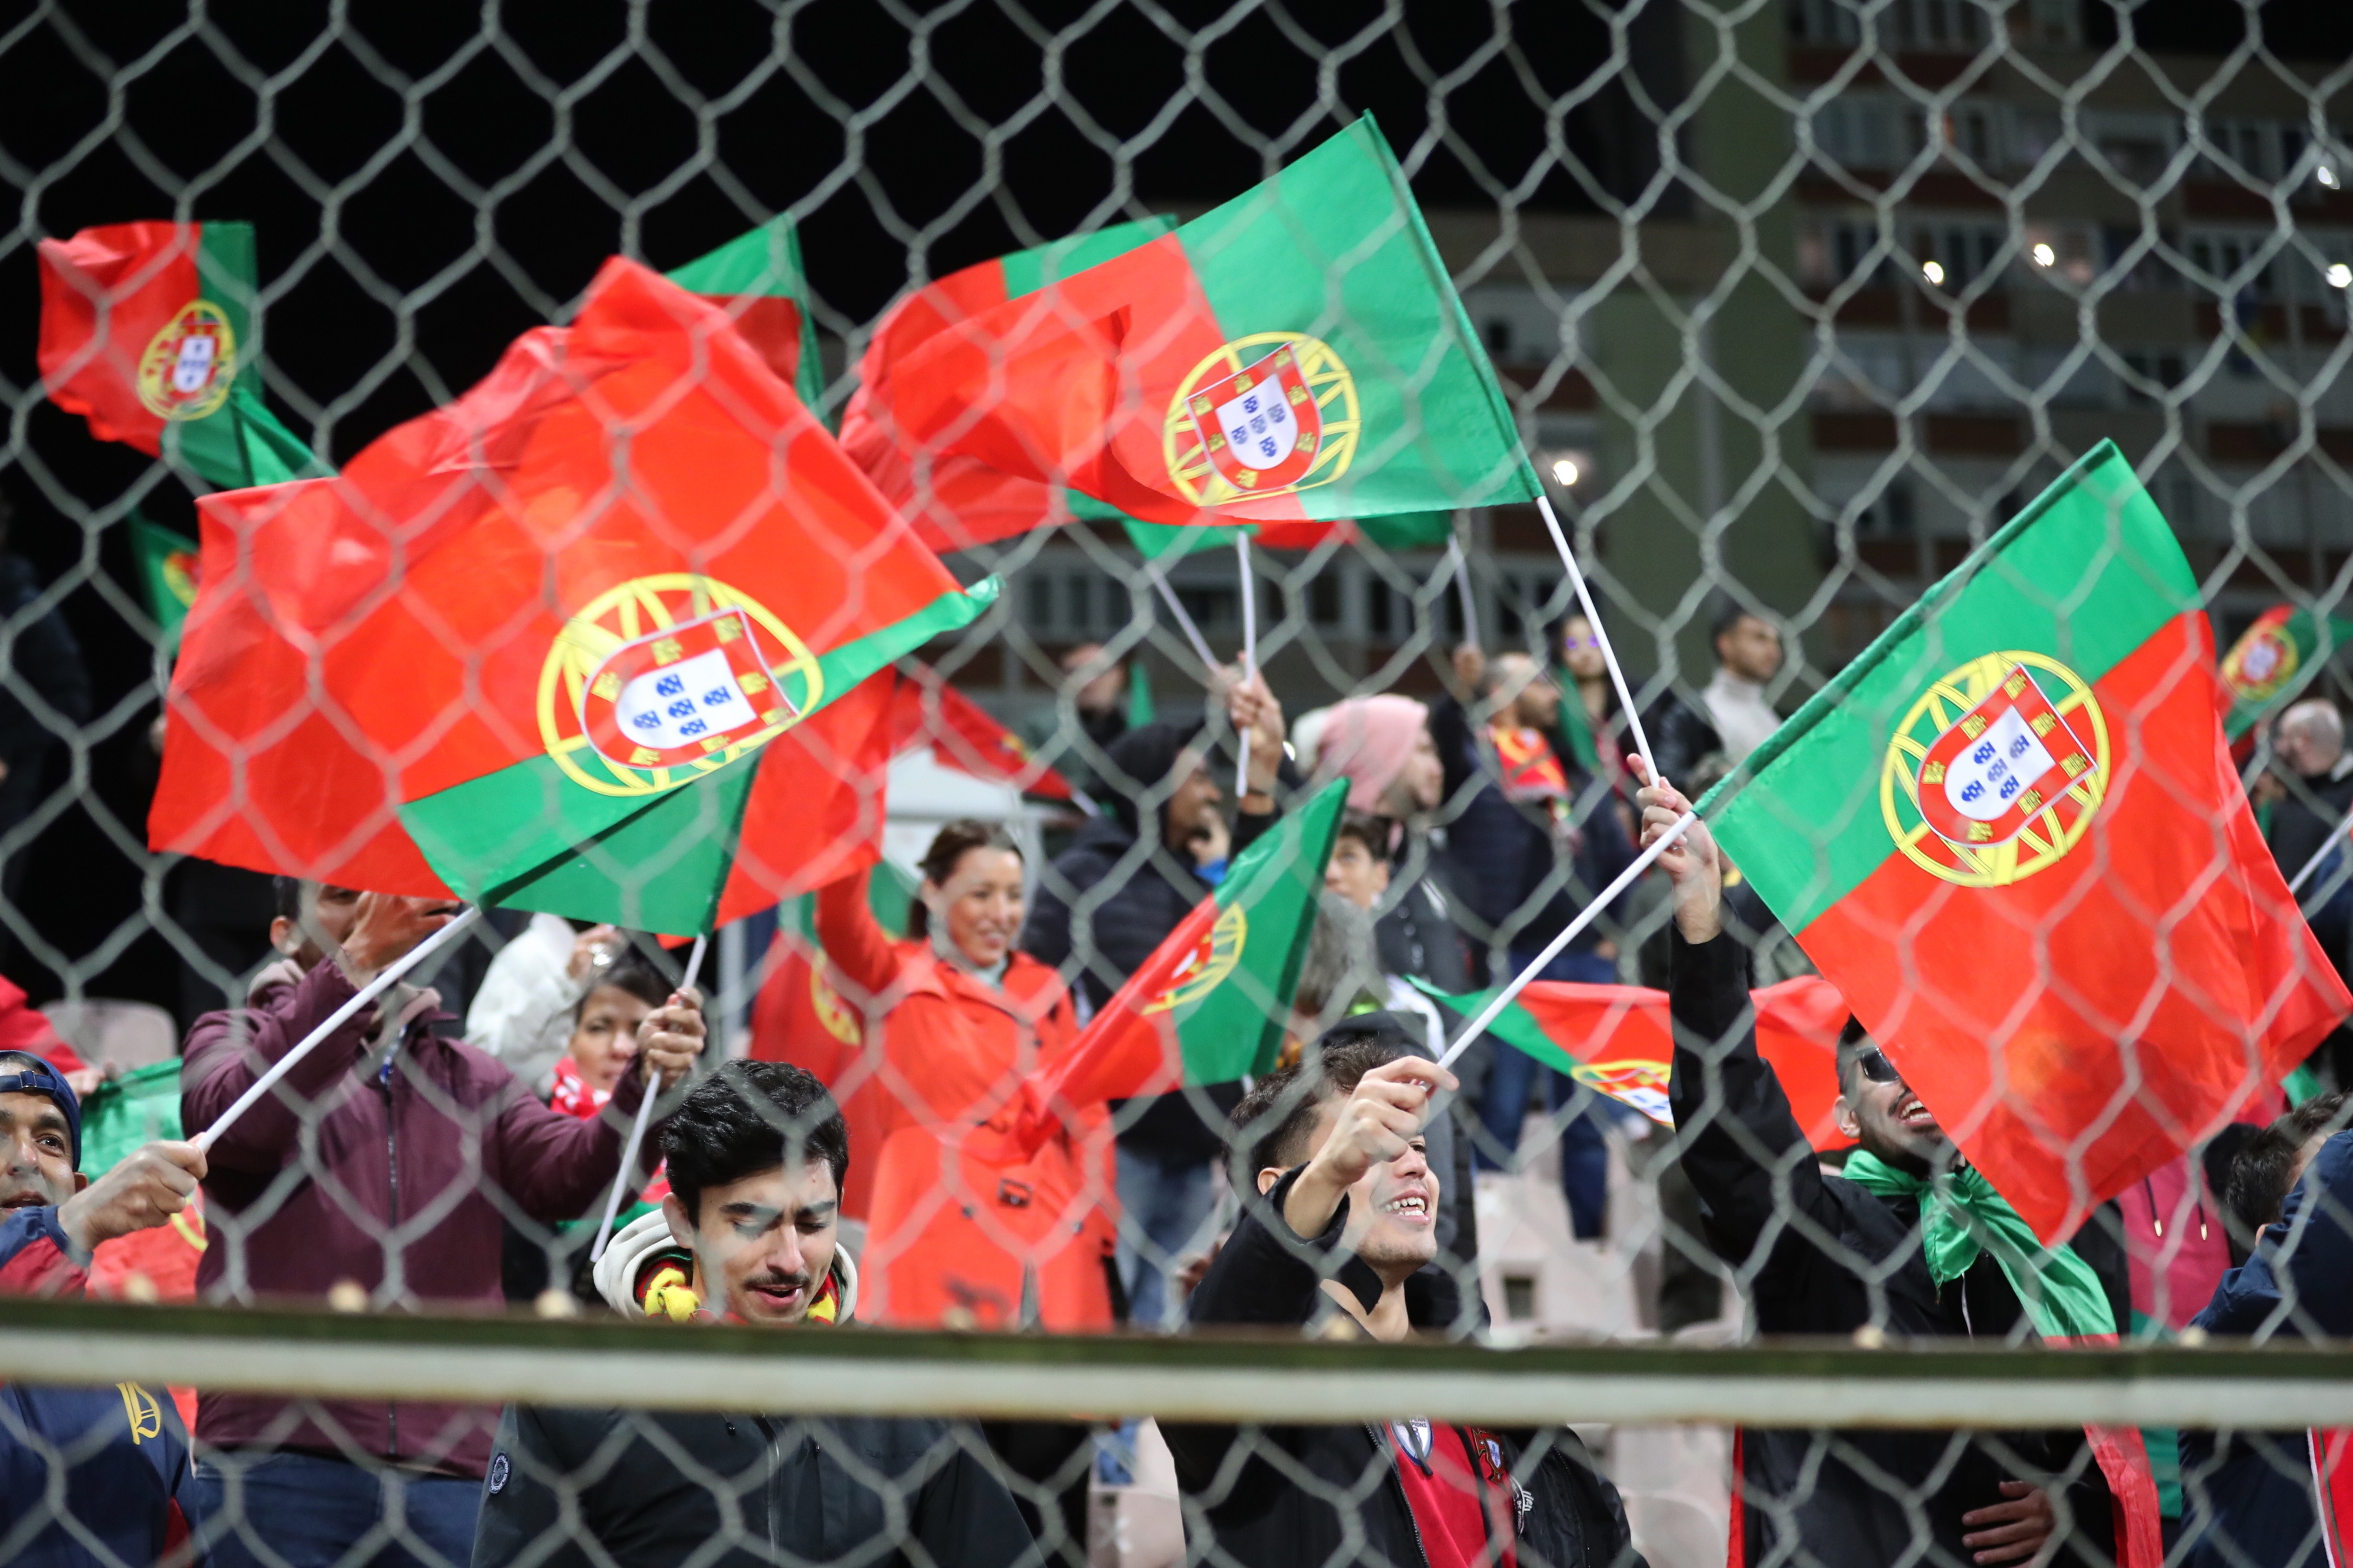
[1842,1149,2115,1340]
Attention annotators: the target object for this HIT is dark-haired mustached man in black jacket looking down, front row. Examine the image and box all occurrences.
[473,1062,1035,1568]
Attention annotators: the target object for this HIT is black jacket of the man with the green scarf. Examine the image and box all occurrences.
[1668,932,2129,1568]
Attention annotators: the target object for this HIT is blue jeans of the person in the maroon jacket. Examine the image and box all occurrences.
[195,1450,482,1568]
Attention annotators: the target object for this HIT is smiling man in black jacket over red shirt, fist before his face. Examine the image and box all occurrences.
[1160,1012,1642,1568]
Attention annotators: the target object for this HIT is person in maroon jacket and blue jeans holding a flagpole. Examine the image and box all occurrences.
[181,880,704,1568]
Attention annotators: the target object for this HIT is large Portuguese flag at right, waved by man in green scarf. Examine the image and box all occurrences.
[1701,443,2353,1243]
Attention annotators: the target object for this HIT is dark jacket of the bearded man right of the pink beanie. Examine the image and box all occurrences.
[1431,697,1633,970]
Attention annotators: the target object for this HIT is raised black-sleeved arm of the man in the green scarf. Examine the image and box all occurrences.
[1633,758,1831,1267]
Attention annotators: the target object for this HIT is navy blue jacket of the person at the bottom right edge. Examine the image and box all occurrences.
[2181,1132,2353,1568]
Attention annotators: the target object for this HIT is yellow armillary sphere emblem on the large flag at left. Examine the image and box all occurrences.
[539,572,826,796]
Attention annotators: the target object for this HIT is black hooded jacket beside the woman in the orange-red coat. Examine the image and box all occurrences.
[1021,723,1280,1163]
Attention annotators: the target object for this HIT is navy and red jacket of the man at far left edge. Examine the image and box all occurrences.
[0,1208,198,1568]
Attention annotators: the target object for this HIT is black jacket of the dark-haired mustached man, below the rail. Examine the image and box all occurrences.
[473,1406,1031,1568]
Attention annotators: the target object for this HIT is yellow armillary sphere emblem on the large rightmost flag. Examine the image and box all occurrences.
[1880,652,2108,888]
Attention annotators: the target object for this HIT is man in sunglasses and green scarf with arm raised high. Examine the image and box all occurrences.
[1633,758,2155,1568]
